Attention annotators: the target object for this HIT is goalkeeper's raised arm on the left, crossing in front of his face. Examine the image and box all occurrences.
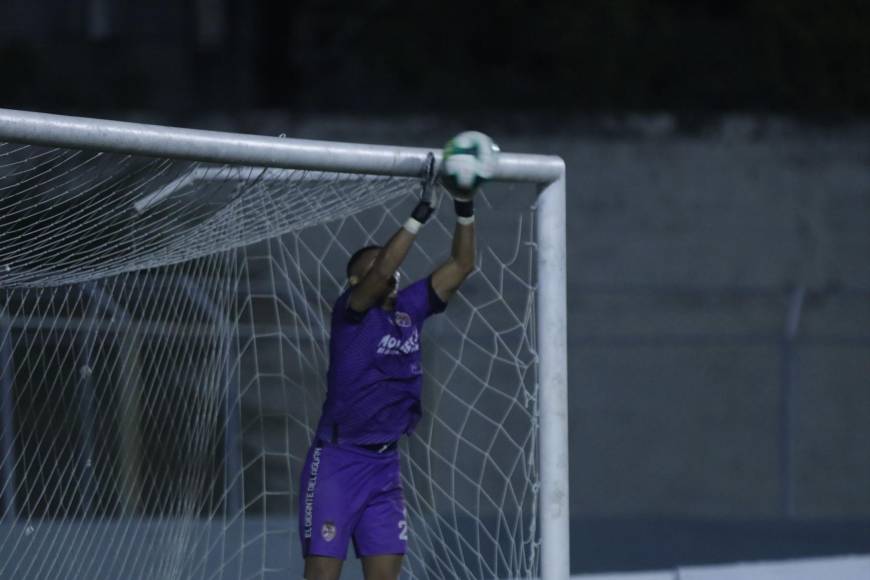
[348,196,433,312]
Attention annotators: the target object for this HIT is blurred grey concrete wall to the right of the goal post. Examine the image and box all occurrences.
[568,121,870,516]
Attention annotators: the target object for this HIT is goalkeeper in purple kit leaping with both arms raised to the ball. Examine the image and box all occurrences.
[299,178,475,580]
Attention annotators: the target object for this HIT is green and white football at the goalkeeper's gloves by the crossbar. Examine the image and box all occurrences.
[441,131,499,199]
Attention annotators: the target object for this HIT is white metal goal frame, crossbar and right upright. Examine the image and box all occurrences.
[0,109,570,580]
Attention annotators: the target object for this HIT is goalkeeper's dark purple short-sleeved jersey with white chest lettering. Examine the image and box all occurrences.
[317,278,446,445]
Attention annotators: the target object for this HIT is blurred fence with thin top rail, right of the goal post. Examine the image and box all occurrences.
[570,285,870,519]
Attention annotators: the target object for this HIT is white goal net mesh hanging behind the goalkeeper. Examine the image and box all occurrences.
[0,143,538,579]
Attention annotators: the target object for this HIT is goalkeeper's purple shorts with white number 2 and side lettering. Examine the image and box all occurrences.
[299,442,408,560]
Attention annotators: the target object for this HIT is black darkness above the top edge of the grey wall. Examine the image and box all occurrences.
[0,0,870,116]
